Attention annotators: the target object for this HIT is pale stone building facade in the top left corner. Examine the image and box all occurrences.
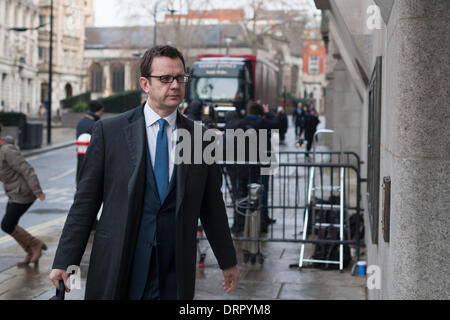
[0,0,39,113]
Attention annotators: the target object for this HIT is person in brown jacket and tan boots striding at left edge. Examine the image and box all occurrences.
[0,124,47,267]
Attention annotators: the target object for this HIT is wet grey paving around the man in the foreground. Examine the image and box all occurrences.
[0,117,366,300]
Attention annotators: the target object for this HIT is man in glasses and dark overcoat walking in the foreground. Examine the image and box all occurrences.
[50,46,239,300]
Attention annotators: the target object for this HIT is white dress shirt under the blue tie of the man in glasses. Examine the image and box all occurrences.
[144,102,177,181]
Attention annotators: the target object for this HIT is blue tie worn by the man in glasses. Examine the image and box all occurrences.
[153,118,169,204]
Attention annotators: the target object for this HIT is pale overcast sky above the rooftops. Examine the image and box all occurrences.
[94,0,315,27]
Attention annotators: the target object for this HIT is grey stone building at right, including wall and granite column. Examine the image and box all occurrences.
[315,0,450,300]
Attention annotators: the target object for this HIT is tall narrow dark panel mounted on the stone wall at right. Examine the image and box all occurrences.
[367,57,382,244]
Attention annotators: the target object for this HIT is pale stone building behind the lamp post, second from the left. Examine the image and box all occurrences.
[38,0,94,113]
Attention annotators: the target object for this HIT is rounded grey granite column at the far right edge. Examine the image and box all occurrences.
[378,0,450,299]
